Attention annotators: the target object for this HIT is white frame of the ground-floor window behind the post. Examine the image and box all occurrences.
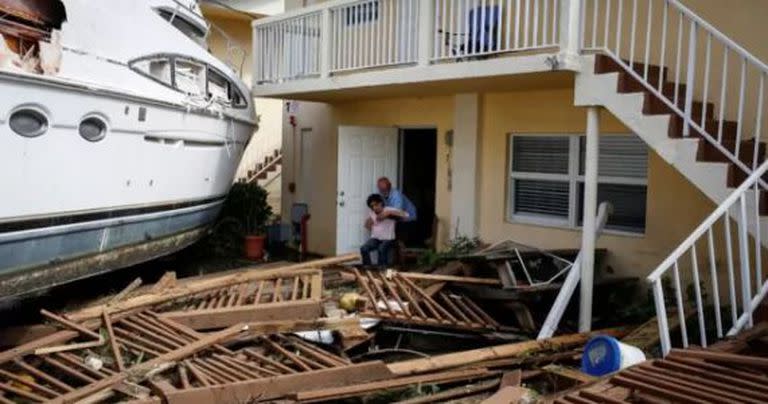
[505,133,648,237]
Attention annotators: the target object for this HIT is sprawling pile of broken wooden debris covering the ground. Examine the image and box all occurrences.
[0,251,767,404]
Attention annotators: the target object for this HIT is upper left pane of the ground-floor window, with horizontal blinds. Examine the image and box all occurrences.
[512,136,569,174]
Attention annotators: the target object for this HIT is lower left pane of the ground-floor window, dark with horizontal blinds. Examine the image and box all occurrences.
[514,179,570,218]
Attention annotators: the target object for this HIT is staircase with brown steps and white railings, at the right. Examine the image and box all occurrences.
[575,0,768,355]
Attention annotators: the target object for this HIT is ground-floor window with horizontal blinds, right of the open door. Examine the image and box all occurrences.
[508,135,648,233]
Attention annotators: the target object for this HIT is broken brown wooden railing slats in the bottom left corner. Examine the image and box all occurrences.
[0,312,238,403]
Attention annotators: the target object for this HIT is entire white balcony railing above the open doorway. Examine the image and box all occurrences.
[253,0,579,85]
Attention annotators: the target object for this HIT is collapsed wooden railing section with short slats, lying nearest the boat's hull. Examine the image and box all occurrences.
[155,270,322,330]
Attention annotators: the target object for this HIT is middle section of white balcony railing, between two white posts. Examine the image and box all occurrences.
[329,0,416,72]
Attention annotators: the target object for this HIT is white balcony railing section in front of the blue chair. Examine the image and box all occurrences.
[432,0,561,60]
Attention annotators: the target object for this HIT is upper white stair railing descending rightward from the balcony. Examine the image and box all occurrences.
[580,0,768,188]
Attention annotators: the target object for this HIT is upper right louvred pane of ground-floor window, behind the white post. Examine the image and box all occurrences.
[579,135,648,178]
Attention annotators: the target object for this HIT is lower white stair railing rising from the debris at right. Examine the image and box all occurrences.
[648,161,768,355]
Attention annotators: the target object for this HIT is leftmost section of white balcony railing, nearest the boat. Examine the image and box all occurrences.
[253,11,322,83]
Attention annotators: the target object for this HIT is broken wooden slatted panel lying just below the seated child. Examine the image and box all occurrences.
[354,269,500,331]
